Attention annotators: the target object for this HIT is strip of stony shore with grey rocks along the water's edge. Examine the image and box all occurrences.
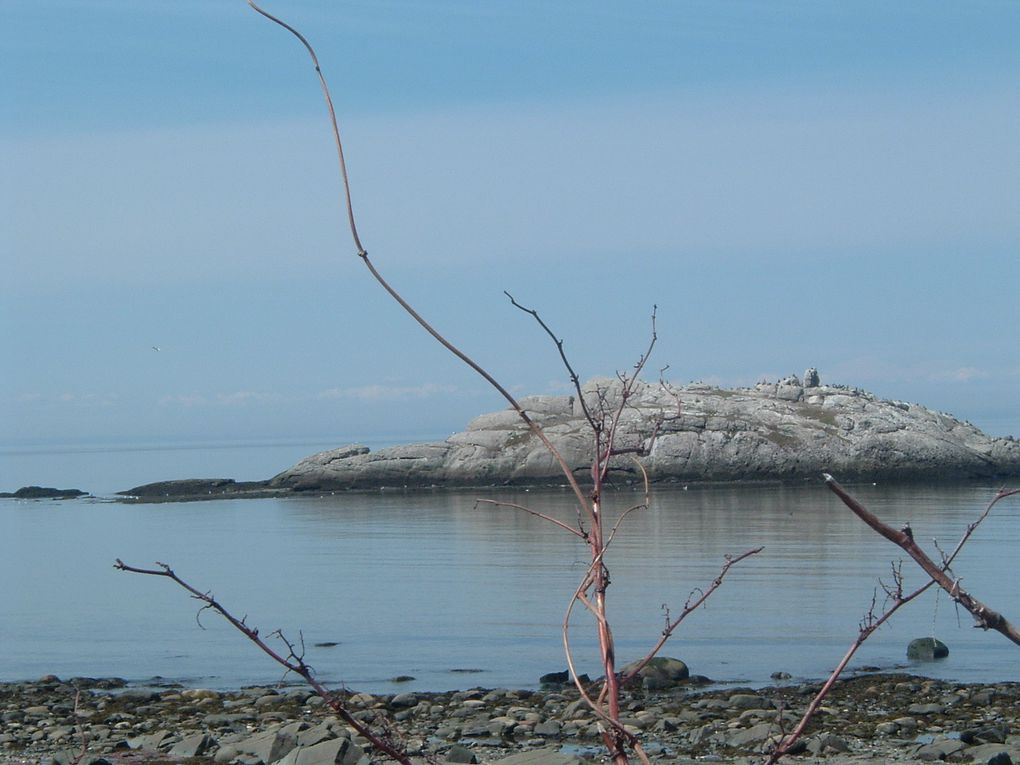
[0,675,1020,765]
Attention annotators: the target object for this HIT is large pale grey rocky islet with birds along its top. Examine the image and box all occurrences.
[268,369,1020,492]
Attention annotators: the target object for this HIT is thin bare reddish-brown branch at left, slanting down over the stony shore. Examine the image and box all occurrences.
[113,558,413,765]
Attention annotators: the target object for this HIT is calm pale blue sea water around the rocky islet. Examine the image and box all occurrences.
[0,442,1020,692]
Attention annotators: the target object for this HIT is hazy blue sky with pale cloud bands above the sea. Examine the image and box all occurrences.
[0,0,1020,448]
